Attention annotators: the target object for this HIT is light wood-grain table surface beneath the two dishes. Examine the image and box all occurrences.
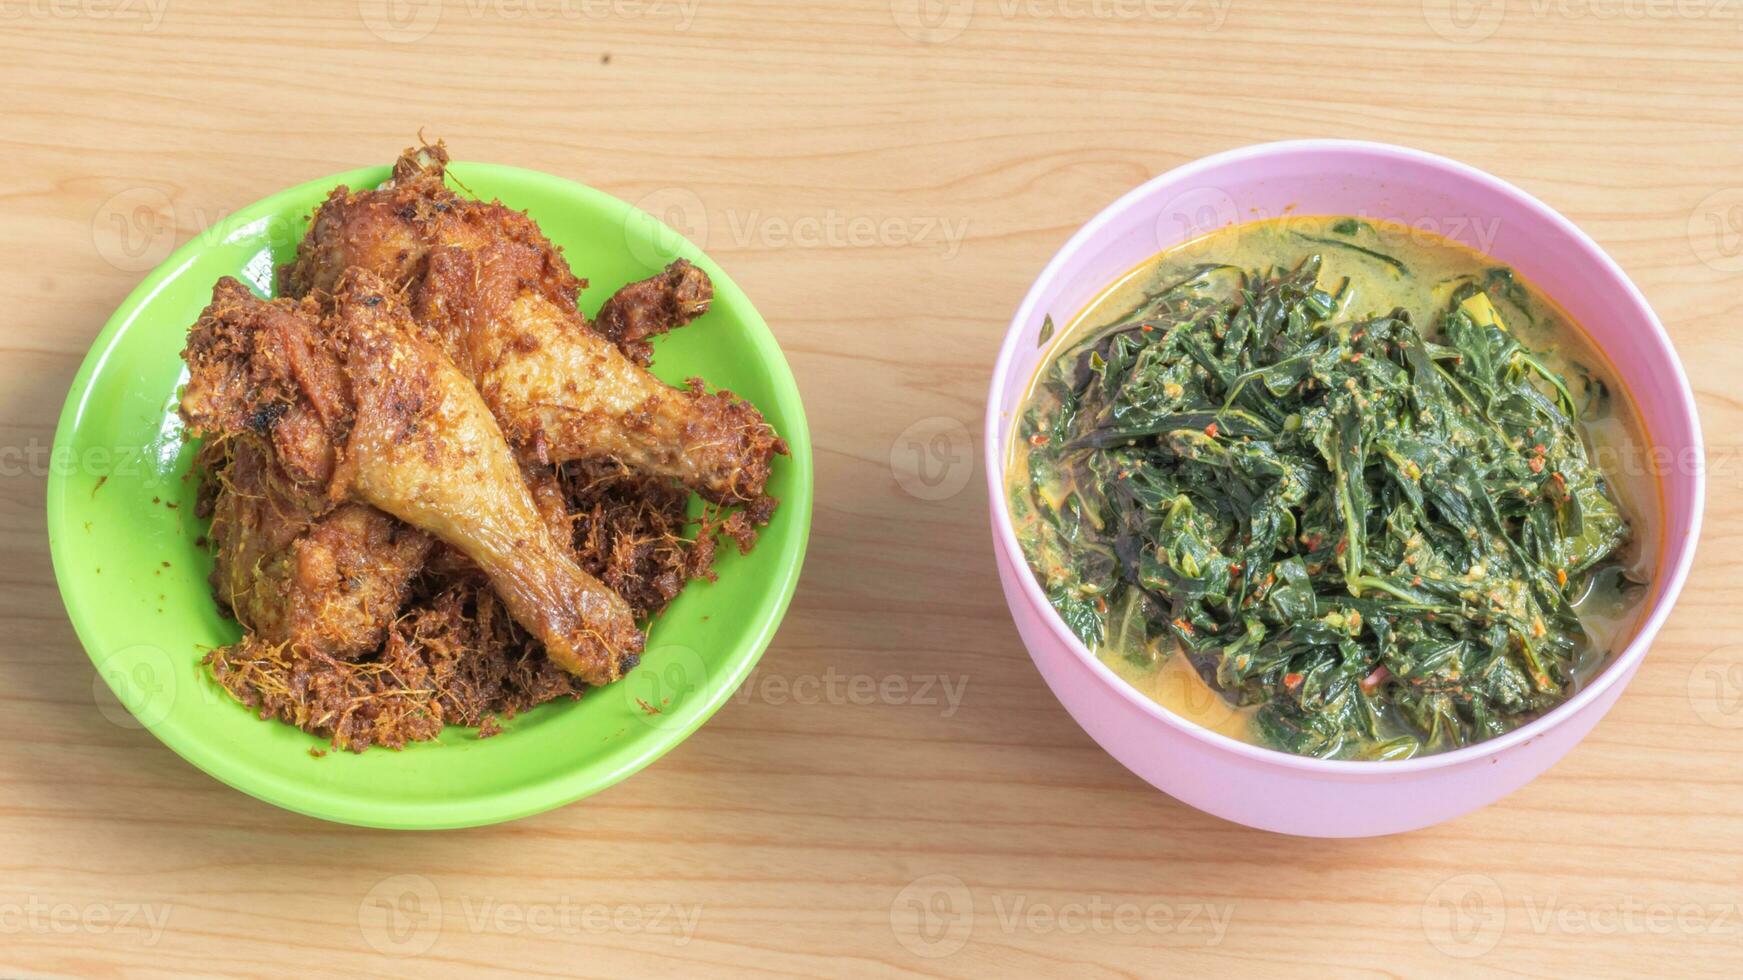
[0,0,1743,977]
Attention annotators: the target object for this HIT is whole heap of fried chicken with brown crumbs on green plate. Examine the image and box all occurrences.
[181,145,786,752]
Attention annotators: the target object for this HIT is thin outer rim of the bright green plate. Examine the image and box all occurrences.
[45,160,816,830]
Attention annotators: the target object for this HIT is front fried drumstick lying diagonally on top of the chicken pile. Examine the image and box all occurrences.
[181,272,643,684]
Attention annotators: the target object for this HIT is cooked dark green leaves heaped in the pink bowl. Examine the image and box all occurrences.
[1013,251,1630,759]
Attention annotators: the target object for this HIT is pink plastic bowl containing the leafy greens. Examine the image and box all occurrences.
[985,140,1705,837]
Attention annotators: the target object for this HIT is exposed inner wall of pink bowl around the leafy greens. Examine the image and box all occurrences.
[987,141,1701,767]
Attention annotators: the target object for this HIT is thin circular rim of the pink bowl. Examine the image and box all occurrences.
[981,140,1706,778]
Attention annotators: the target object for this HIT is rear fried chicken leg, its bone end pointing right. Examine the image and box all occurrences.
[286,145,786,520]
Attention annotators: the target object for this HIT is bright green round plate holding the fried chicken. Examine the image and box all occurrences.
[49,162,812,828]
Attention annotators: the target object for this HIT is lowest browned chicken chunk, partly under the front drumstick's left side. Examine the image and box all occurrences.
[200,432,432,661]
